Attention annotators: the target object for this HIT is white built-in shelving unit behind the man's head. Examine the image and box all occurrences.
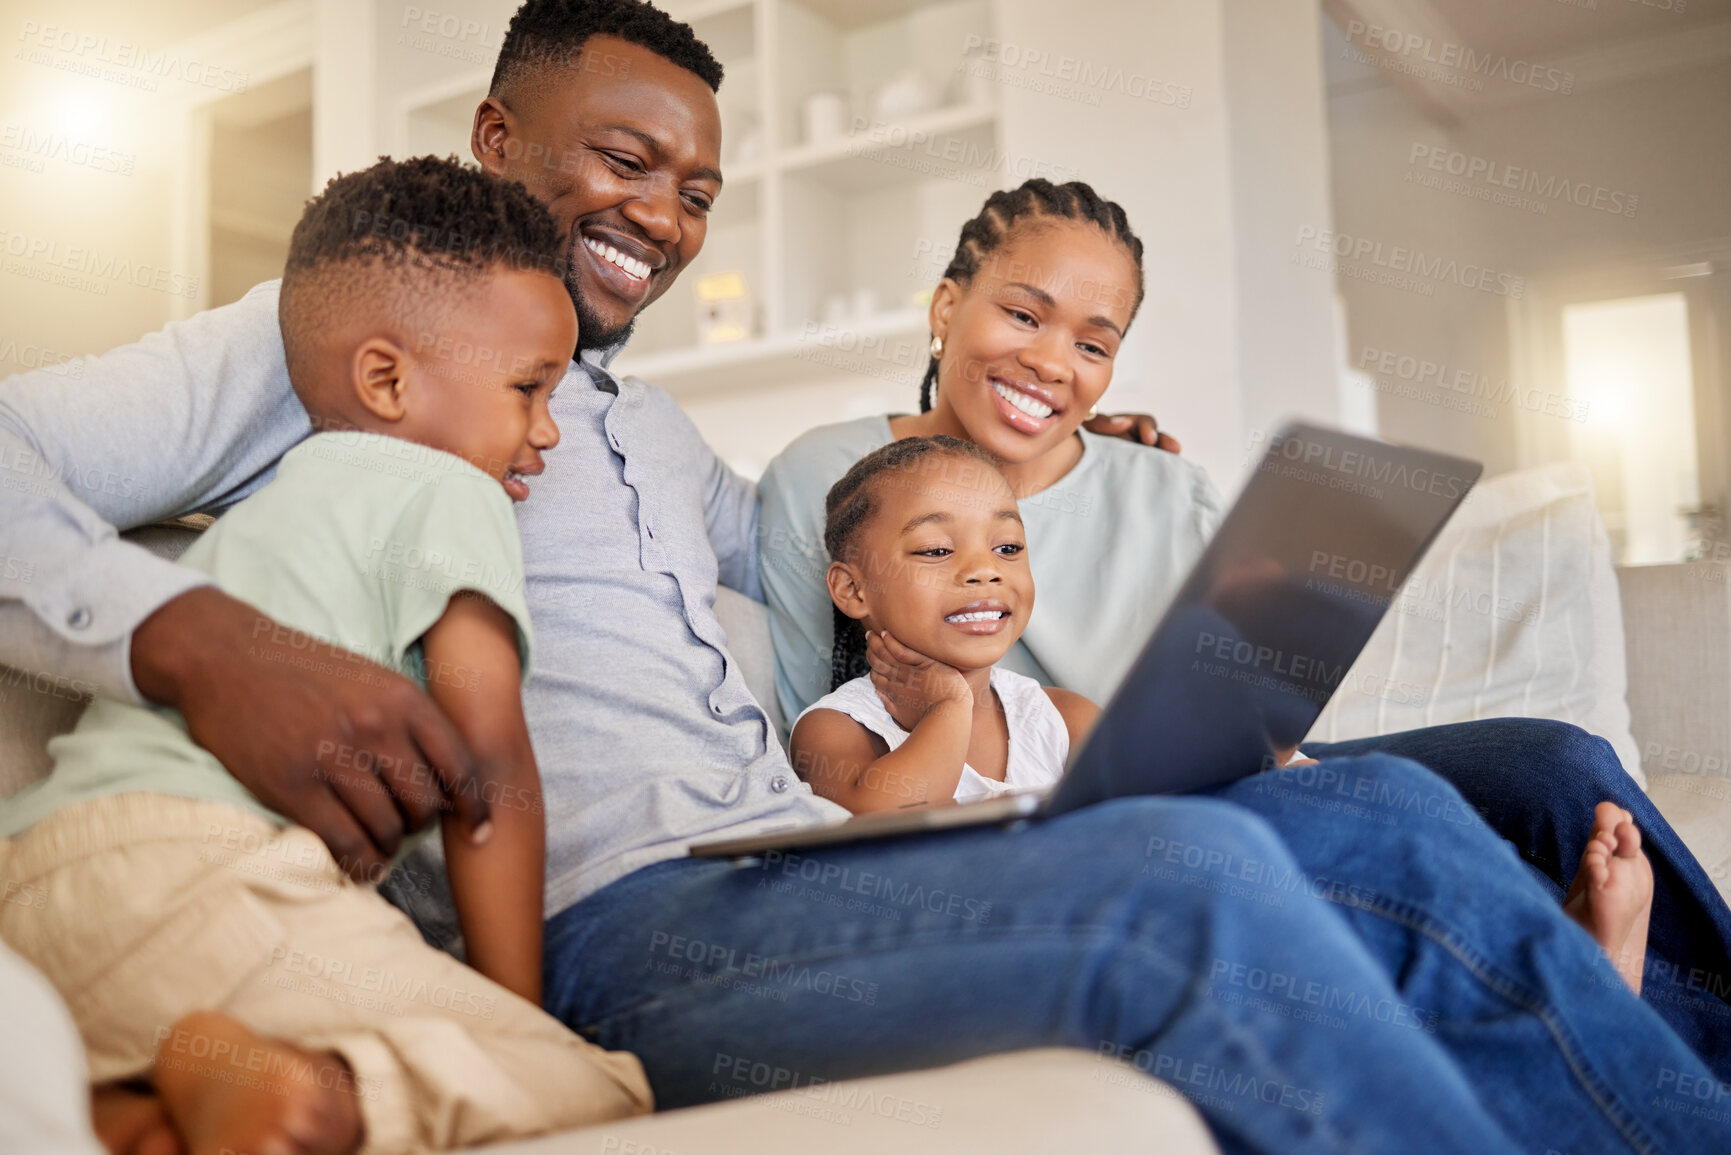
[395,0,1004,400]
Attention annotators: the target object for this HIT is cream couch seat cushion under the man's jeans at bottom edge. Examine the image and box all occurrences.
[467,1049,1217,1155]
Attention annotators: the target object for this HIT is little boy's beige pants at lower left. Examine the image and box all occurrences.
[0,793,651,1153]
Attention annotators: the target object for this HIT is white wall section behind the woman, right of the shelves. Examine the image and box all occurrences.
[999,0,1338,490]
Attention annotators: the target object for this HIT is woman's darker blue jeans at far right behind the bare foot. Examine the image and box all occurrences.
[1303,719,1731,1081]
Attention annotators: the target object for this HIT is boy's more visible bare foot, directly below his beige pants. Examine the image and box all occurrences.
[151,1011,362,1155]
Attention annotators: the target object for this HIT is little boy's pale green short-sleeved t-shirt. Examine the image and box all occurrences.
[0,433,530,836]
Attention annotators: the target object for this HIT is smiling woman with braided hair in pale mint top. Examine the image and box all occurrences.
[758,180,1222,719]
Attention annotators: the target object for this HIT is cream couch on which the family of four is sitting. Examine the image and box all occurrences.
[0,464,1731,1155]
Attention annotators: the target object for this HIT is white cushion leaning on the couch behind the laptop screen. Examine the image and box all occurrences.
[1310,462,1646,786]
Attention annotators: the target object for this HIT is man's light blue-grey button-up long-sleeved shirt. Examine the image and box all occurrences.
[0,282,846,921]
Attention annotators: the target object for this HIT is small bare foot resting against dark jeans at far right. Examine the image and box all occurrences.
[1563,802,1653,994]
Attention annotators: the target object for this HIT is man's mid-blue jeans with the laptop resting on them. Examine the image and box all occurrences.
[545,755,1731,1153]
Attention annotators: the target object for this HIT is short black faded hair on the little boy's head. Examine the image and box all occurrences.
[277,156,564,409]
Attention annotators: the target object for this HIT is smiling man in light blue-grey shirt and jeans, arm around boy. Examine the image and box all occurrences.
[0,0,1712,1153]
